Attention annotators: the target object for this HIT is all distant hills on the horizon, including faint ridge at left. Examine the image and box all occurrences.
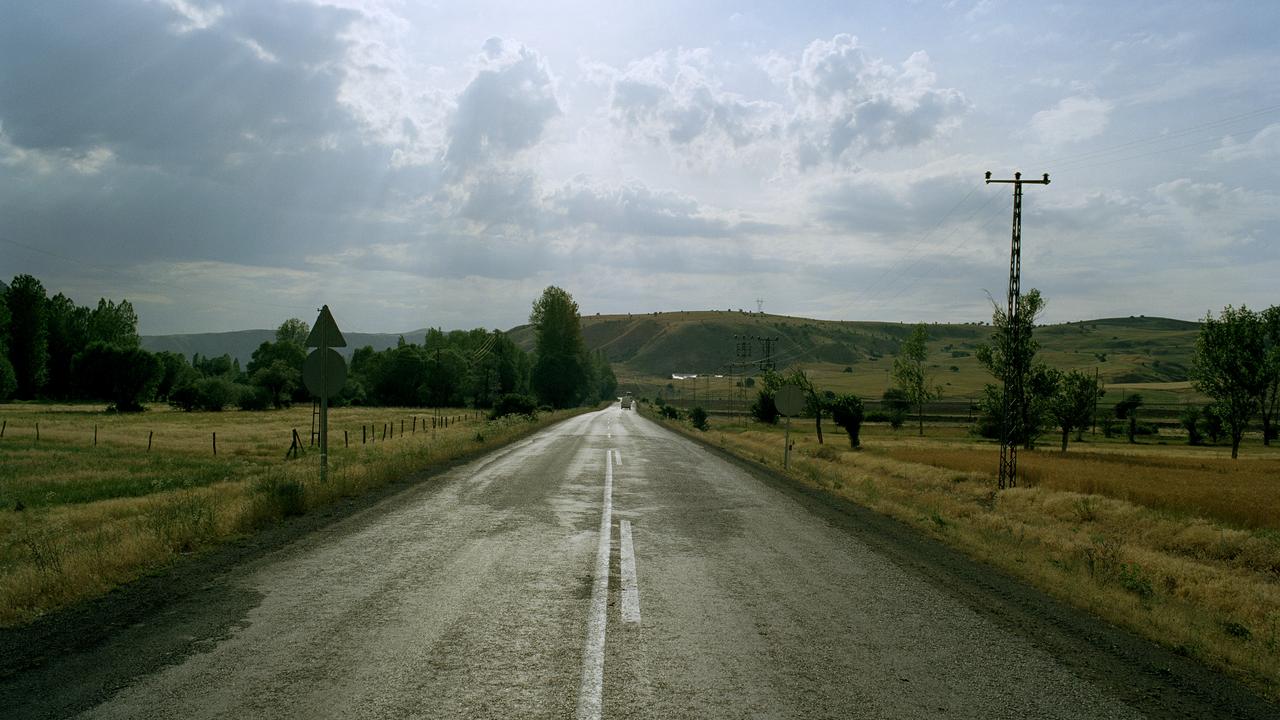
[142,310,1199,383]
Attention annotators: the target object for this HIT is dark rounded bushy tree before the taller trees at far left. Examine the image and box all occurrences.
[73,341,161,413]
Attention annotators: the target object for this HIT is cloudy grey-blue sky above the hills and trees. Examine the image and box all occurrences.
[0,0,1280,334]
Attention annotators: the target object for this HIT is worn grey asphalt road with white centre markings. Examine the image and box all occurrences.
[5,406,1265,719]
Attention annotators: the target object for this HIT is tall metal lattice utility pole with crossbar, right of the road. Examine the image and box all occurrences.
[987,170,1048,488]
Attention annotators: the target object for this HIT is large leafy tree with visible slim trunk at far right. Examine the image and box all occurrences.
[1190,305,1267,459]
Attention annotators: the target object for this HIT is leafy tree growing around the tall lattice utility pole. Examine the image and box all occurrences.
[975,288,1056,448]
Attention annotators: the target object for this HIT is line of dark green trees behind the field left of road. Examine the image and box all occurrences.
[0,275,617,413]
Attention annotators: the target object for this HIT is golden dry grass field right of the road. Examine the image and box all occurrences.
[650,414,1280,700]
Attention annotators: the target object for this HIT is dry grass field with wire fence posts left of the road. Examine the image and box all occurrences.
[0,405,586,626]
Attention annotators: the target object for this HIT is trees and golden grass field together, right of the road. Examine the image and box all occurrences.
[645,290,1280,700]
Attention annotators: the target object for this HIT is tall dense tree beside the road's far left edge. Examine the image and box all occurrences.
[529,286,589,407]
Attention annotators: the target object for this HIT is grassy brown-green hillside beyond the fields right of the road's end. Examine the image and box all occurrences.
[509,310,1199,401]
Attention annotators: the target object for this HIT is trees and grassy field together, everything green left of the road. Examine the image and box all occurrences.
[0,275,617,626]
